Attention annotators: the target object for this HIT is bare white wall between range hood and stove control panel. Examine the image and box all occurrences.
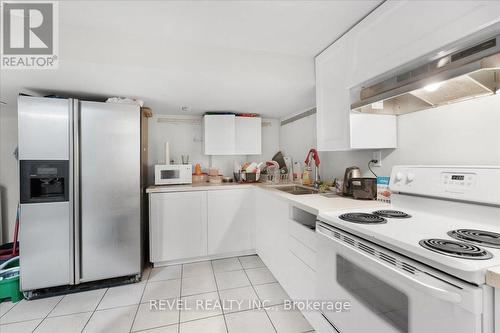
[382,95,500,173]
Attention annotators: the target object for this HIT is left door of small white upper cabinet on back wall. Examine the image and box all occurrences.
[203,115,236,155]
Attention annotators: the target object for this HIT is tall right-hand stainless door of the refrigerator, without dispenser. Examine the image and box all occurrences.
[76,102,141,282]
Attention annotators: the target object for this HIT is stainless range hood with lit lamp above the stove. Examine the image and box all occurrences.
[351,36,500,115]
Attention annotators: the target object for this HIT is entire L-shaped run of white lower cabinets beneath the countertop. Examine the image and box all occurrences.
[149,188,333,332]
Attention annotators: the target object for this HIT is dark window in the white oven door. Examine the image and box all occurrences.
[336,255,409,333]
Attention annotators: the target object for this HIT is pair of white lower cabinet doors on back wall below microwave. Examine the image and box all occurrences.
[149,188,255,265]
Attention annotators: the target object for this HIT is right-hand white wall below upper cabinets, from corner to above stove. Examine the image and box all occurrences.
[280,95,500,179]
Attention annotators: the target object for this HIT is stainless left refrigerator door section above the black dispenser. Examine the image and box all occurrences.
[18,96,70,160]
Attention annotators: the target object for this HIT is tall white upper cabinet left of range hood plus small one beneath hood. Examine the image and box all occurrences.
[316,32,397,151]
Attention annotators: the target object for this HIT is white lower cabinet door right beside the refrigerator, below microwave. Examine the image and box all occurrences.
[149,191,207,263]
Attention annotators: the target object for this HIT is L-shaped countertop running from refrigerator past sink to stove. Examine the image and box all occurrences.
[146,183,387,215]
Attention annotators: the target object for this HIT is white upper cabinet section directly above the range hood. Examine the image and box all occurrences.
[348,1,500,86]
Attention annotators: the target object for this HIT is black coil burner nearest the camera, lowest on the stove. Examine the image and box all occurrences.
[419,238,493,260]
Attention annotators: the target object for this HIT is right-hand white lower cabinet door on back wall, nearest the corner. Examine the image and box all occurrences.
[207,189,255,255]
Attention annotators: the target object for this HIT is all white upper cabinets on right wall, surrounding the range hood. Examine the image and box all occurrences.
[316,1,500,151]
